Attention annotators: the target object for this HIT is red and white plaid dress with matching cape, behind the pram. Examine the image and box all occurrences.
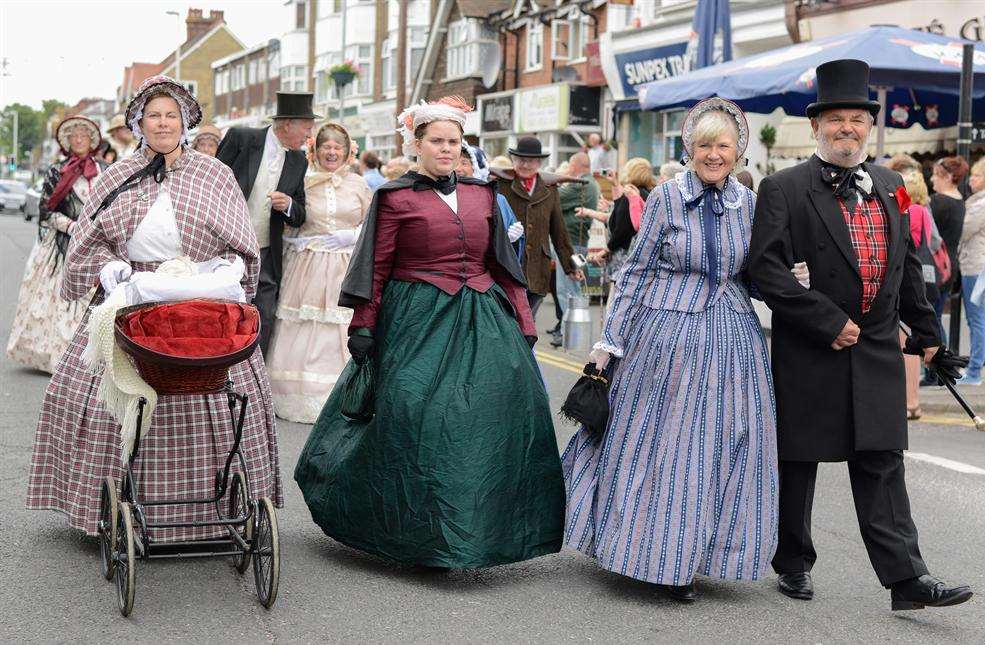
[27,148,283,541]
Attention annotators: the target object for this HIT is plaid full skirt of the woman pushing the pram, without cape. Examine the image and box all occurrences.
[27,306,283,542]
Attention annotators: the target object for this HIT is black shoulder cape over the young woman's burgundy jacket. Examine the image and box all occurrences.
[339,175,527,308]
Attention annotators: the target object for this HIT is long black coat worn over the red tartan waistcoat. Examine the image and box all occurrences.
[749,157,940,461]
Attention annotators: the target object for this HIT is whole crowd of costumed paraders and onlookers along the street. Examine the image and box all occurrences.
[8,60,985,609]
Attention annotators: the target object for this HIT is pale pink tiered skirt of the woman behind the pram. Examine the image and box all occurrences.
[267,243,352,423]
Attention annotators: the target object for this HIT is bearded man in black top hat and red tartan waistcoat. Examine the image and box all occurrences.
[749,60,972,610]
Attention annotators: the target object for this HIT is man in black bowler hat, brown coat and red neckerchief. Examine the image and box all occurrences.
[495,137,585,316]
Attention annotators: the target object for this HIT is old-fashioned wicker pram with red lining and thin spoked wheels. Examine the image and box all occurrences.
[99,299,280,616]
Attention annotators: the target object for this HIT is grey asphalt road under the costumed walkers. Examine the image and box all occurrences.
[0,213,985,643]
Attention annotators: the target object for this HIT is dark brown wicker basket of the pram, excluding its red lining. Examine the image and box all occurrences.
[114,299,260,394]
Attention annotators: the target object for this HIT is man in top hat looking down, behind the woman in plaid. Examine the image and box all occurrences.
[216,92,320,356]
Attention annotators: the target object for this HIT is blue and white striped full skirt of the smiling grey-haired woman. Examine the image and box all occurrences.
[561,302,778,585]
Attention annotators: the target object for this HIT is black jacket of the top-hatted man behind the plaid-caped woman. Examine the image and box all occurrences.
[216,128,308,283]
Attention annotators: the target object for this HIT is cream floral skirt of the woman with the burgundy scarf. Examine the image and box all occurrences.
[7,231,90,374]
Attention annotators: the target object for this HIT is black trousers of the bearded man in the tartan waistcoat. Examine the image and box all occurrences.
[773,450,927,587]
